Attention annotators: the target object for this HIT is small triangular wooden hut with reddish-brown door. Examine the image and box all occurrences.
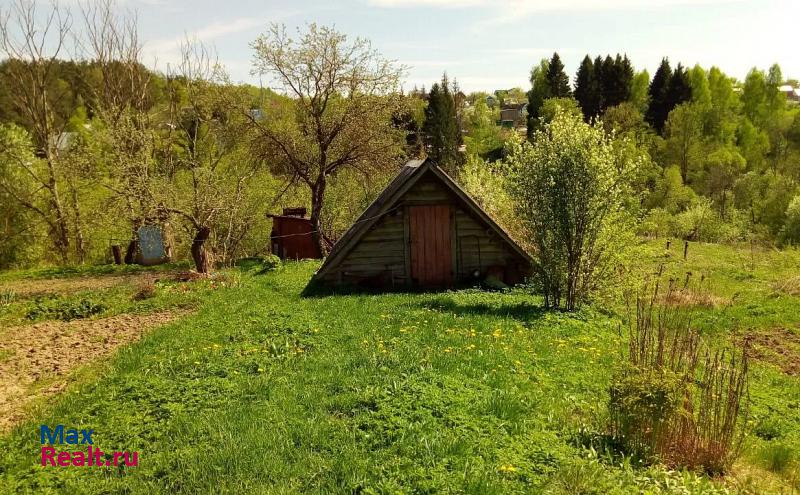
[312,160,533,289]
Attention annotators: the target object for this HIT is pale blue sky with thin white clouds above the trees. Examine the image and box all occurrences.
[125,0,800,91]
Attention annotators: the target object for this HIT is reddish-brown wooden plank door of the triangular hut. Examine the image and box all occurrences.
[408,205,453,287]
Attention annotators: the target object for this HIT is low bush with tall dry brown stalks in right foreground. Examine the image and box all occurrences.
[609,281,748,474]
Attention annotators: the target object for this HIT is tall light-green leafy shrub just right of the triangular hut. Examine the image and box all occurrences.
[508,112,636,310]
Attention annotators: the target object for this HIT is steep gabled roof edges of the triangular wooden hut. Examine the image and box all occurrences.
[314,159,533,279]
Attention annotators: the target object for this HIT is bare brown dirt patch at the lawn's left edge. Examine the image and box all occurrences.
[0,312,187,432]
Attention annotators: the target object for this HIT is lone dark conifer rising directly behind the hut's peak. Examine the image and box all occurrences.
[422,74,461,174]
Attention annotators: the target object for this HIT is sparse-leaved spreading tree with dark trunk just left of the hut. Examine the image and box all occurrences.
[250,24,404,253]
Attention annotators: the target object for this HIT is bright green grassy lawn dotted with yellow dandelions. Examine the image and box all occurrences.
[0,241,800,494]
